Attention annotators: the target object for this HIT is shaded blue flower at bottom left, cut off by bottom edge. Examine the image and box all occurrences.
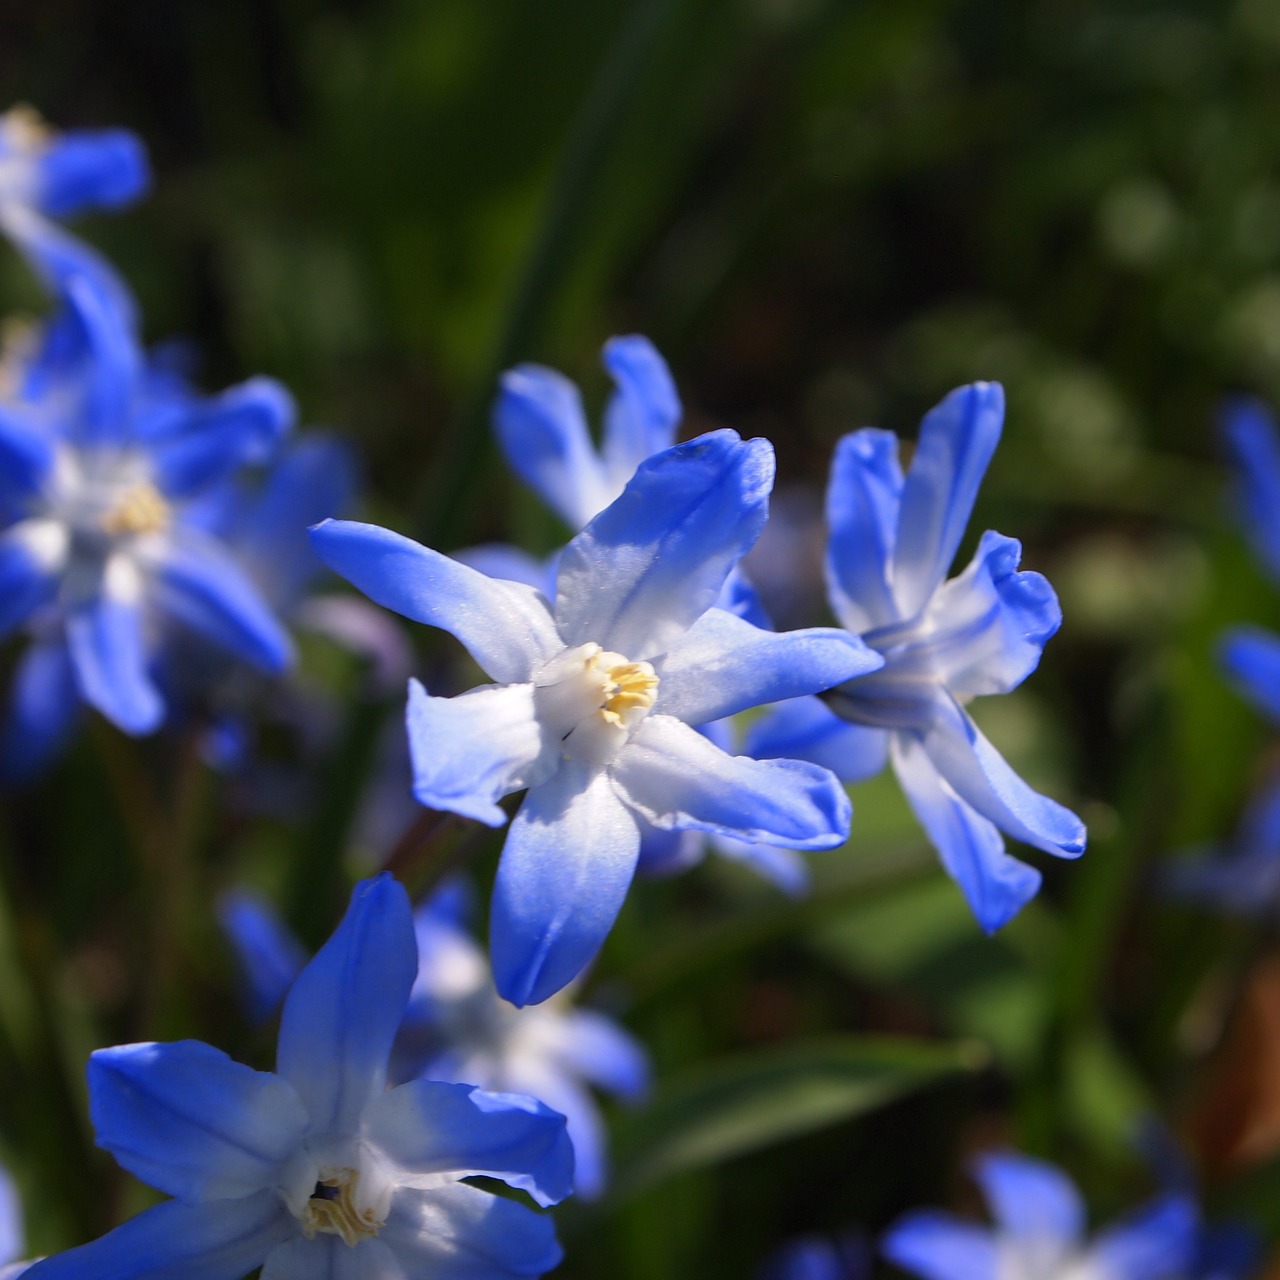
[28,874,572,1280]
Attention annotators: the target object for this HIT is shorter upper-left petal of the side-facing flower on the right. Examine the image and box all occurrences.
[827,428,902,631]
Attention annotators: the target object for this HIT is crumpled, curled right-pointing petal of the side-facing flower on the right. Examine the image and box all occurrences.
[920,530,1062,698]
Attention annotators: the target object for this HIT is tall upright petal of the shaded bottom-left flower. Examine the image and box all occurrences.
[276,872,417,1133]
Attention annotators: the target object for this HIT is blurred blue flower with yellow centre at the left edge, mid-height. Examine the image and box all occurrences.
[0,276,293,776]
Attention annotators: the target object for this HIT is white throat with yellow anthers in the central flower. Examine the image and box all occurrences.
[534,641,659,764]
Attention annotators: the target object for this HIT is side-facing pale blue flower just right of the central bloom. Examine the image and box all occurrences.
[746,383,1085,932]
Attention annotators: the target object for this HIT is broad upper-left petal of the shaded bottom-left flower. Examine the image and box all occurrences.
[88,1041,307,1201]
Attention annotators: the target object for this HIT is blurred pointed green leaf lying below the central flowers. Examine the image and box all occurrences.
[613,1036,987,1199]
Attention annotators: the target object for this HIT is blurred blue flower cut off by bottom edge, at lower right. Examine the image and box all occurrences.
[881,1153,1198,1280]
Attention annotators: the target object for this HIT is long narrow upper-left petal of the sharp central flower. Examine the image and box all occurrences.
[311,520,563,684]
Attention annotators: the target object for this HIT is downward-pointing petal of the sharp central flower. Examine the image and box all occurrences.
[489,762,640,1005]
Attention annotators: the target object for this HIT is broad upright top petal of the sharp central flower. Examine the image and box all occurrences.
[556,430,773,662]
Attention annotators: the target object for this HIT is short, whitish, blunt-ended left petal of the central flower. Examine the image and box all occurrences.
[404,680,559,827]
